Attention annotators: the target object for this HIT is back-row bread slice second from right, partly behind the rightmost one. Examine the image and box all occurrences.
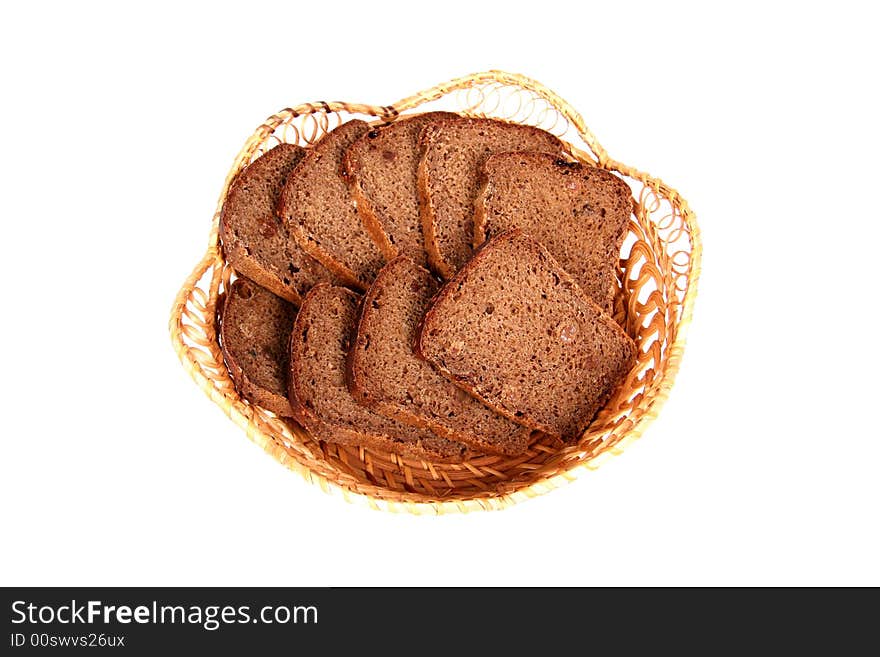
[418,117,565,279]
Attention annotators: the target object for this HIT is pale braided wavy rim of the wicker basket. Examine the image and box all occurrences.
[169,70,702,515]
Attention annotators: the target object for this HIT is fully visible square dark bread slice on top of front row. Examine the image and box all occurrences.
[418,229,636,440]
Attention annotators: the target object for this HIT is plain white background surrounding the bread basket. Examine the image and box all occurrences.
[0,2,880,586]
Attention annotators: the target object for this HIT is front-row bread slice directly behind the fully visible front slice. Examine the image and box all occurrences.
[347,256,531,456]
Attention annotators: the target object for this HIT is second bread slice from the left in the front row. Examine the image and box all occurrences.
[288,284,466,462]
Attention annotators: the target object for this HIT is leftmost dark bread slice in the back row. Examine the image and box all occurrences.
[220,144,334,305]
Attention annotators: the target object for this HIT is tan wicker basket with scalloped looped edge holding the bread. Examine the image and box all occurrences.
[170,71,700,514]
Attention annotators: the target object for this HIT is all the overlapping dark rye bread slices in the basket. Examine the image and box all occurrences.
[220,112,636,462]
